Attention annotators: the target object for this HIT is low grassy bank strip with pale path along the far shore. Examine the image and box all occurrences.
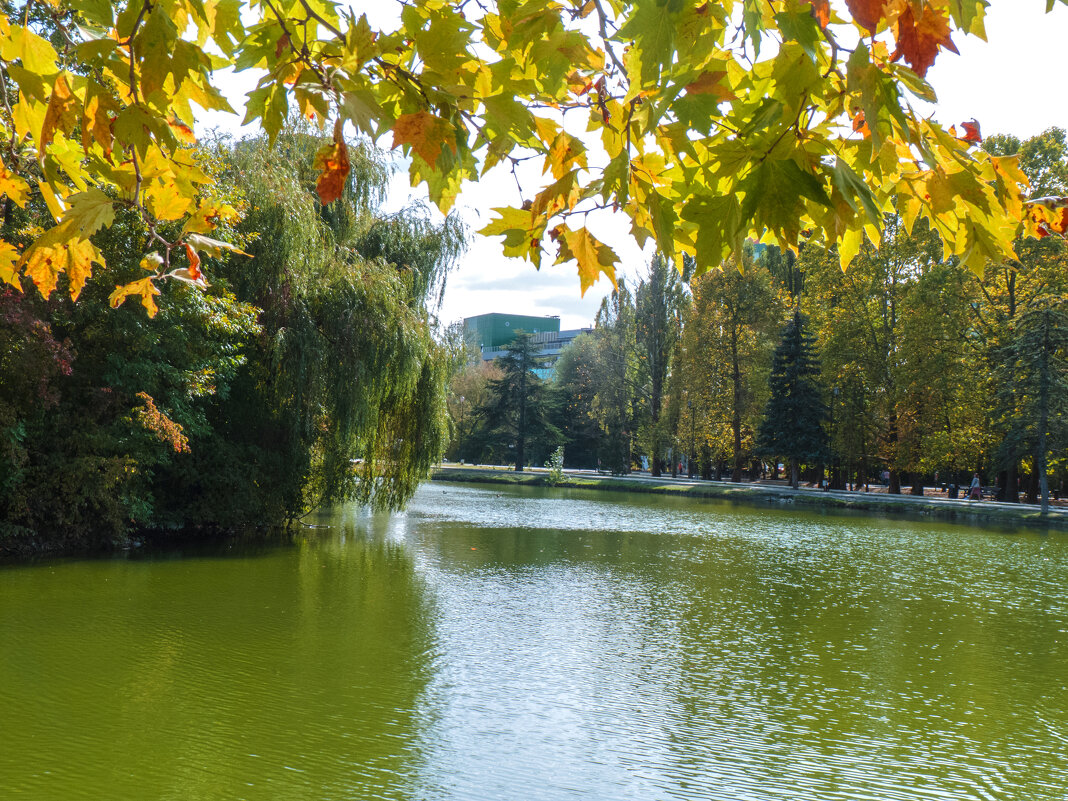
[430,465,1068,531]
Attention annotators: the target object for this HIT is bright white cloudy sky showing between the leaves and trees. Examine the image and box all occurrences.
[198,0,1068,329]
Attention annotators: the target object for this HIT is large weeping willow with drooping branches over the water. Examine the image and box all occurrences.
[182,129,462,519]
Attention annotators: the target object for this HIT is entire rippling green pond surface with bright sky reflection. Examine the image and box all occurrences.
[0,485,1068,801]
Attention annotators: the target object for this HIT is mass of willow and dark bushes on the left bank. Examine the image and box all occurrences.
[0,129,464,549]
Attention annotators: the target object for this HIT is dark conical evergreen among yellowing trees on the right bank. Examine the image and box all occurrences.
[757,311,829,488]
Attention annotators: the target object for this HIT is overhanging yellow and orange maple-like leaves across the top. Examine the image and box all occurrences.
[0,0,1068,314]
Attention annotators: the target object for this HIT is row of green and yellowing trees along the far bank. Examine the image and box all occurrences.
[447,129,1068,508]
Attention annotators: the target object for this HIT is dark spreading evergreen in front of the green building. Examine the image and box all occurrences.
[478,332,560,473]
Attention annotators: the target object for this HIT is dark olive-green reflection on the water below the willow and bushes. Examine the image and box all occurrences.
[0,528,429,801]
